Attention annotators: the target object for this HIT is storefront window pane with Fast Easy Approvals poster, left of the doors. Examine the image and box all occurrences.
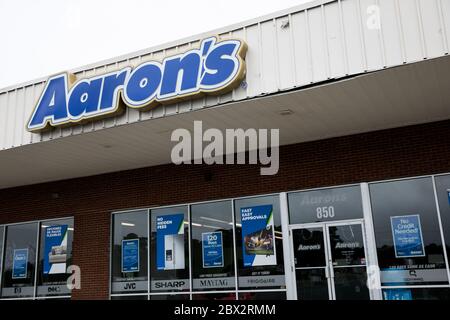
[234,195,285,289]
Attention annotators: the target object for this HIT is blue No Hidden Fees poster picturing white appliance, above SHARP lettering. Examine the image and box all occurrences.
[156,213,185,270]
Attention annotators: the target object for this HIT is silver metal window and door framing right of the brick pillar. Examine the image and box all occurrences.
[106,173,450,300]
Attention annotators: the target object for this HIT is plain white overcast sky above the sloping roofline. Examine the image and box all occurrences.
[0,0,311,88]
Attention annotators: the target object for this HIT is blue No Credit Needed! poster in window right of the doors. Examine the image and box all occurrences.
[391,215,425,258]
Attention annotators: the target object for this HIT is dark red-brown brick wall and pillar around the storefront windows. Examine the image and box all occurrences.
[0,121,450,299]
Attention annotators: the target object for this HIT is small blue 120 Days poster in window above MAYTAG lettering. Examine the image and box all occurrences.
[202,231,223,268]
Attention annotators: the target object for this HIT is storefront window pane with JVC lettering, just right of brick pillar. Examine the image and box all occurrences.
[111,210,148,293]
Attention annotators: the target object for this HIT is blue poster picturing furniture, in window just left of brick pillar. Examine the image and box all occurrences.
[44,225,68,274]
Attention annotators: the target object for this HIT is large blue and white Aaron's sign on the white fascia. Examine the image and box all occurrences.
[27,37,247,132]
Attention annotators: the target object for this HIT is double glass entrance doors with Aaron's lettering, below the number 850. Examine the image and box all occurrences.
[291,221,370,300]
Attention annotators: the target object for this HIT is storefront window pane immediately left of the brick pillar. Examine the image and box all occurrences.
[37,219,74,296]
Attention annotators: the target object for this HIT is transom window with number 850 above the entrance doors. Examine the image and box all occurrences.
[288,186,363,224]
